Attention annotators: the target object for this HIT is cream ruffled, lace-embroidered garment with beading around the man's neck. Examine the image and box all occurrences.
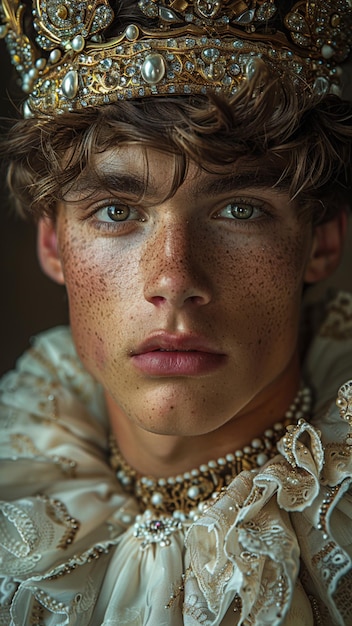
[0,294,352,626]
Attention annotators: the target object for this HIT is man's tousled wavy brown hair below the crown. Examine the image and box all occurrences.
[2,67,352,221]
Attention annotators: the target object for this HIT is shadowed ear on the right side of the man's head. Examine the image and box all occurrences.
[304,211,347,283]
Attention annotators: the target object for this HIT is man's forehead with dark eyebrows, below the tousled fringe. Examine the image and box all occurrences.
[66,145,289,199]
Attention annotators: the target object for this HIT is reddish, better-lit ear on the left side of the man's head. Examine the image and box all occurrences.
[37,217,65,285]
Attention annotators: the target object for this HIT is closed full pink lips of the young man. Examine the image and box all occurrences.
[132,332,226,376]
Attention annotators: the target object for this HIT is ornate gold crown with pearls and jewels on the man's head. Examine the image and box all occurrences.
[0,0,352,115]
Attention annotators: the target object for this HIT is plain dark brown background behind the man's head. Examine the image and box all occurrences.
[0,41,352,375]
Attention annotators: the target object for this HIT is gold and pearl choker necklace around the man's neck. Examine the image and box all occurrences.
[109,387,312,521]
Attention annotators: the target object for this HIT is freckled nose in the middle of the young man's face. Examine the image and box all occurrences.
[143,218,211,308]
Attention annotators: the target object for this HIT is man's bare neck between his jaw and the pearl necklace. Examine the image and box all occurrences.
[106,352,299,477]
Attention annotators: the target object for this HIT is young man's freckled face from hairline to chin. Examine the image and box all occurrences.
[51,146,312,435]
